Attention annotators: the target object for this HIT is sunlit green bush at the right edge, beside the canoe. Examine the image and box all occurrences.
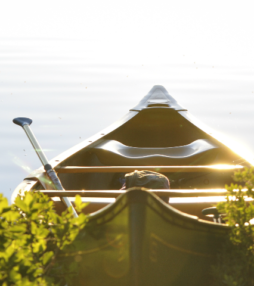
[213,168,254,286]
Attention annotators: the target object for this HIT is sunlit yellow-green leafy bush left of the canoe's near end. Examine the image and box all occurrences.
[0,192,87,286]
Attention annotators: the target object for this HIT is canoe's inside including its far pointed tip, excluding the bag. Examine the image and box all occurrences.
[21,86,249,222]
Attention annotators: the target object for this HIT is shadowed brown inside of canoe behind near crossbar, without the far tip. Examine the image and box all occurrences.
[52,108,244,193]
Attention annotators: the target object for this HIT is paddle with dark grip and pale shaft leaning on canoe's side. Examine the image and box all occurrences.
[13,117,78,217]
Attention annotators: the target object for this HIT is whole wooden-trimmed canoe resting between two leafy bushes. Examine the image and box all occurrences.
[13,86,251,286]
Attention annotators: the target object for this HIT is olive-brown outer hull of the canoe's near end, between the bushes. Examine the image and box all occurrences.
[64,189,228,286]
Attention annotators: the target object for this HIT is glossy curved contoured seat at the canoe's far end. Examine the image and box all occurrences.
[91,139,219,166]
